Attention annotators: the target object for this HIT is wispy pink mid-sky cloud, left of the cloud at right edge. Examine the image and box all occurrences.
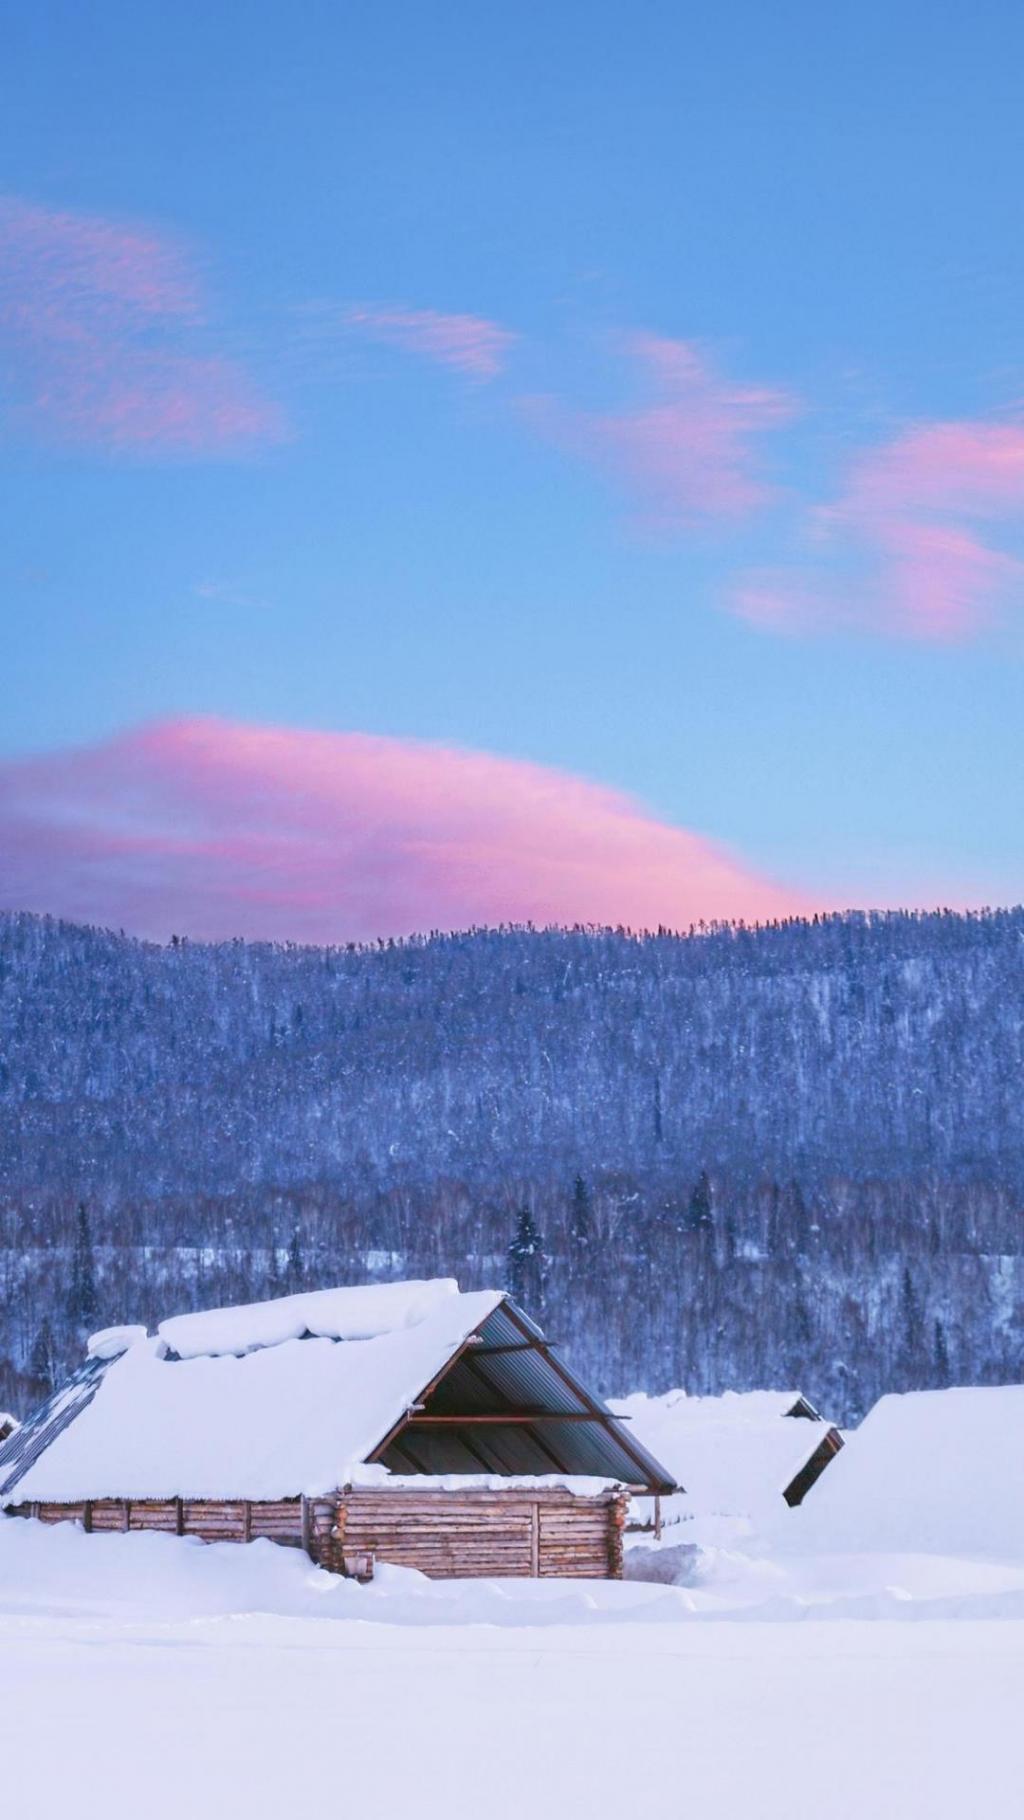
[524,335,798,530]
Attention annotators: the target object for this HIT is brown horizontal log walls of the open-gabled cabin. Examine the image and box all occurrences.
[7,1487,627,1580]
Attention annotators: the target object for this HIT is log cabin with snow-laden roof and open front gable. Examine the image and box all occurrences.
[0,1279,675,1578]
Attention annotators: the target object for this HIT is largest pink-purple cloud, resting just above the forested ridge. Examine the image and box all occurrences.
[0,719,806,943]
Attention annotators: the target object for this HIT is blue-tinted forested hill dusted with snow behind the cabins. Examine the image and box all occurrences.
[0,910,1024,1414]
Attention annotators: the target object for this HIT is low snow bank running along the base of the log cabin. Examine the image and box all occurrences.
[0,1516,1024,1642]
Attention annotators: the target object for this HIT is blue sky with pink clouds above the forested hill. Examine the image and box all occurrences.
[0,0,1024,941]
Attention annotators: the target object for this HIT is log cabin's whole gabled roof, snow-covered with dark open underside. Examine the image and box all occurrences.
[0,1279,673,1503]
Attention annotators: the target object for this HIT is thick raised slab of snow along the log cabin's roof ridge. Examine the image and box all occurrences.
[158,1276,458,1360]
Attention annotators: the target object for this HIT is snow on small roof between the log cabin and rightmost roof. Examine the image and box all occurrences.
[609,1390,842,1543]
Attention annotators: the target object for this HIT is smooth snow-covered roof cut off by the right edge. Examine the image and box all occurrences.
[795,1385,1024,1560]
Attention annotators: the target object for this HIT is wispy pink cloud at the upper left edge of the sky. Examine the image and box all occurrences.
[0,197,280,455]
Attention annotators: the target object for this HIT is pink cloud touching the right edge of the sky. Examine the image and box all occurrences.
[729,422,1024,644]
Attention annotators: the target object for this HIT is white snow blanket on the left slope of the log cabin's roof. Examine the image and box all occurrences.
[9,1285,502,1503]
